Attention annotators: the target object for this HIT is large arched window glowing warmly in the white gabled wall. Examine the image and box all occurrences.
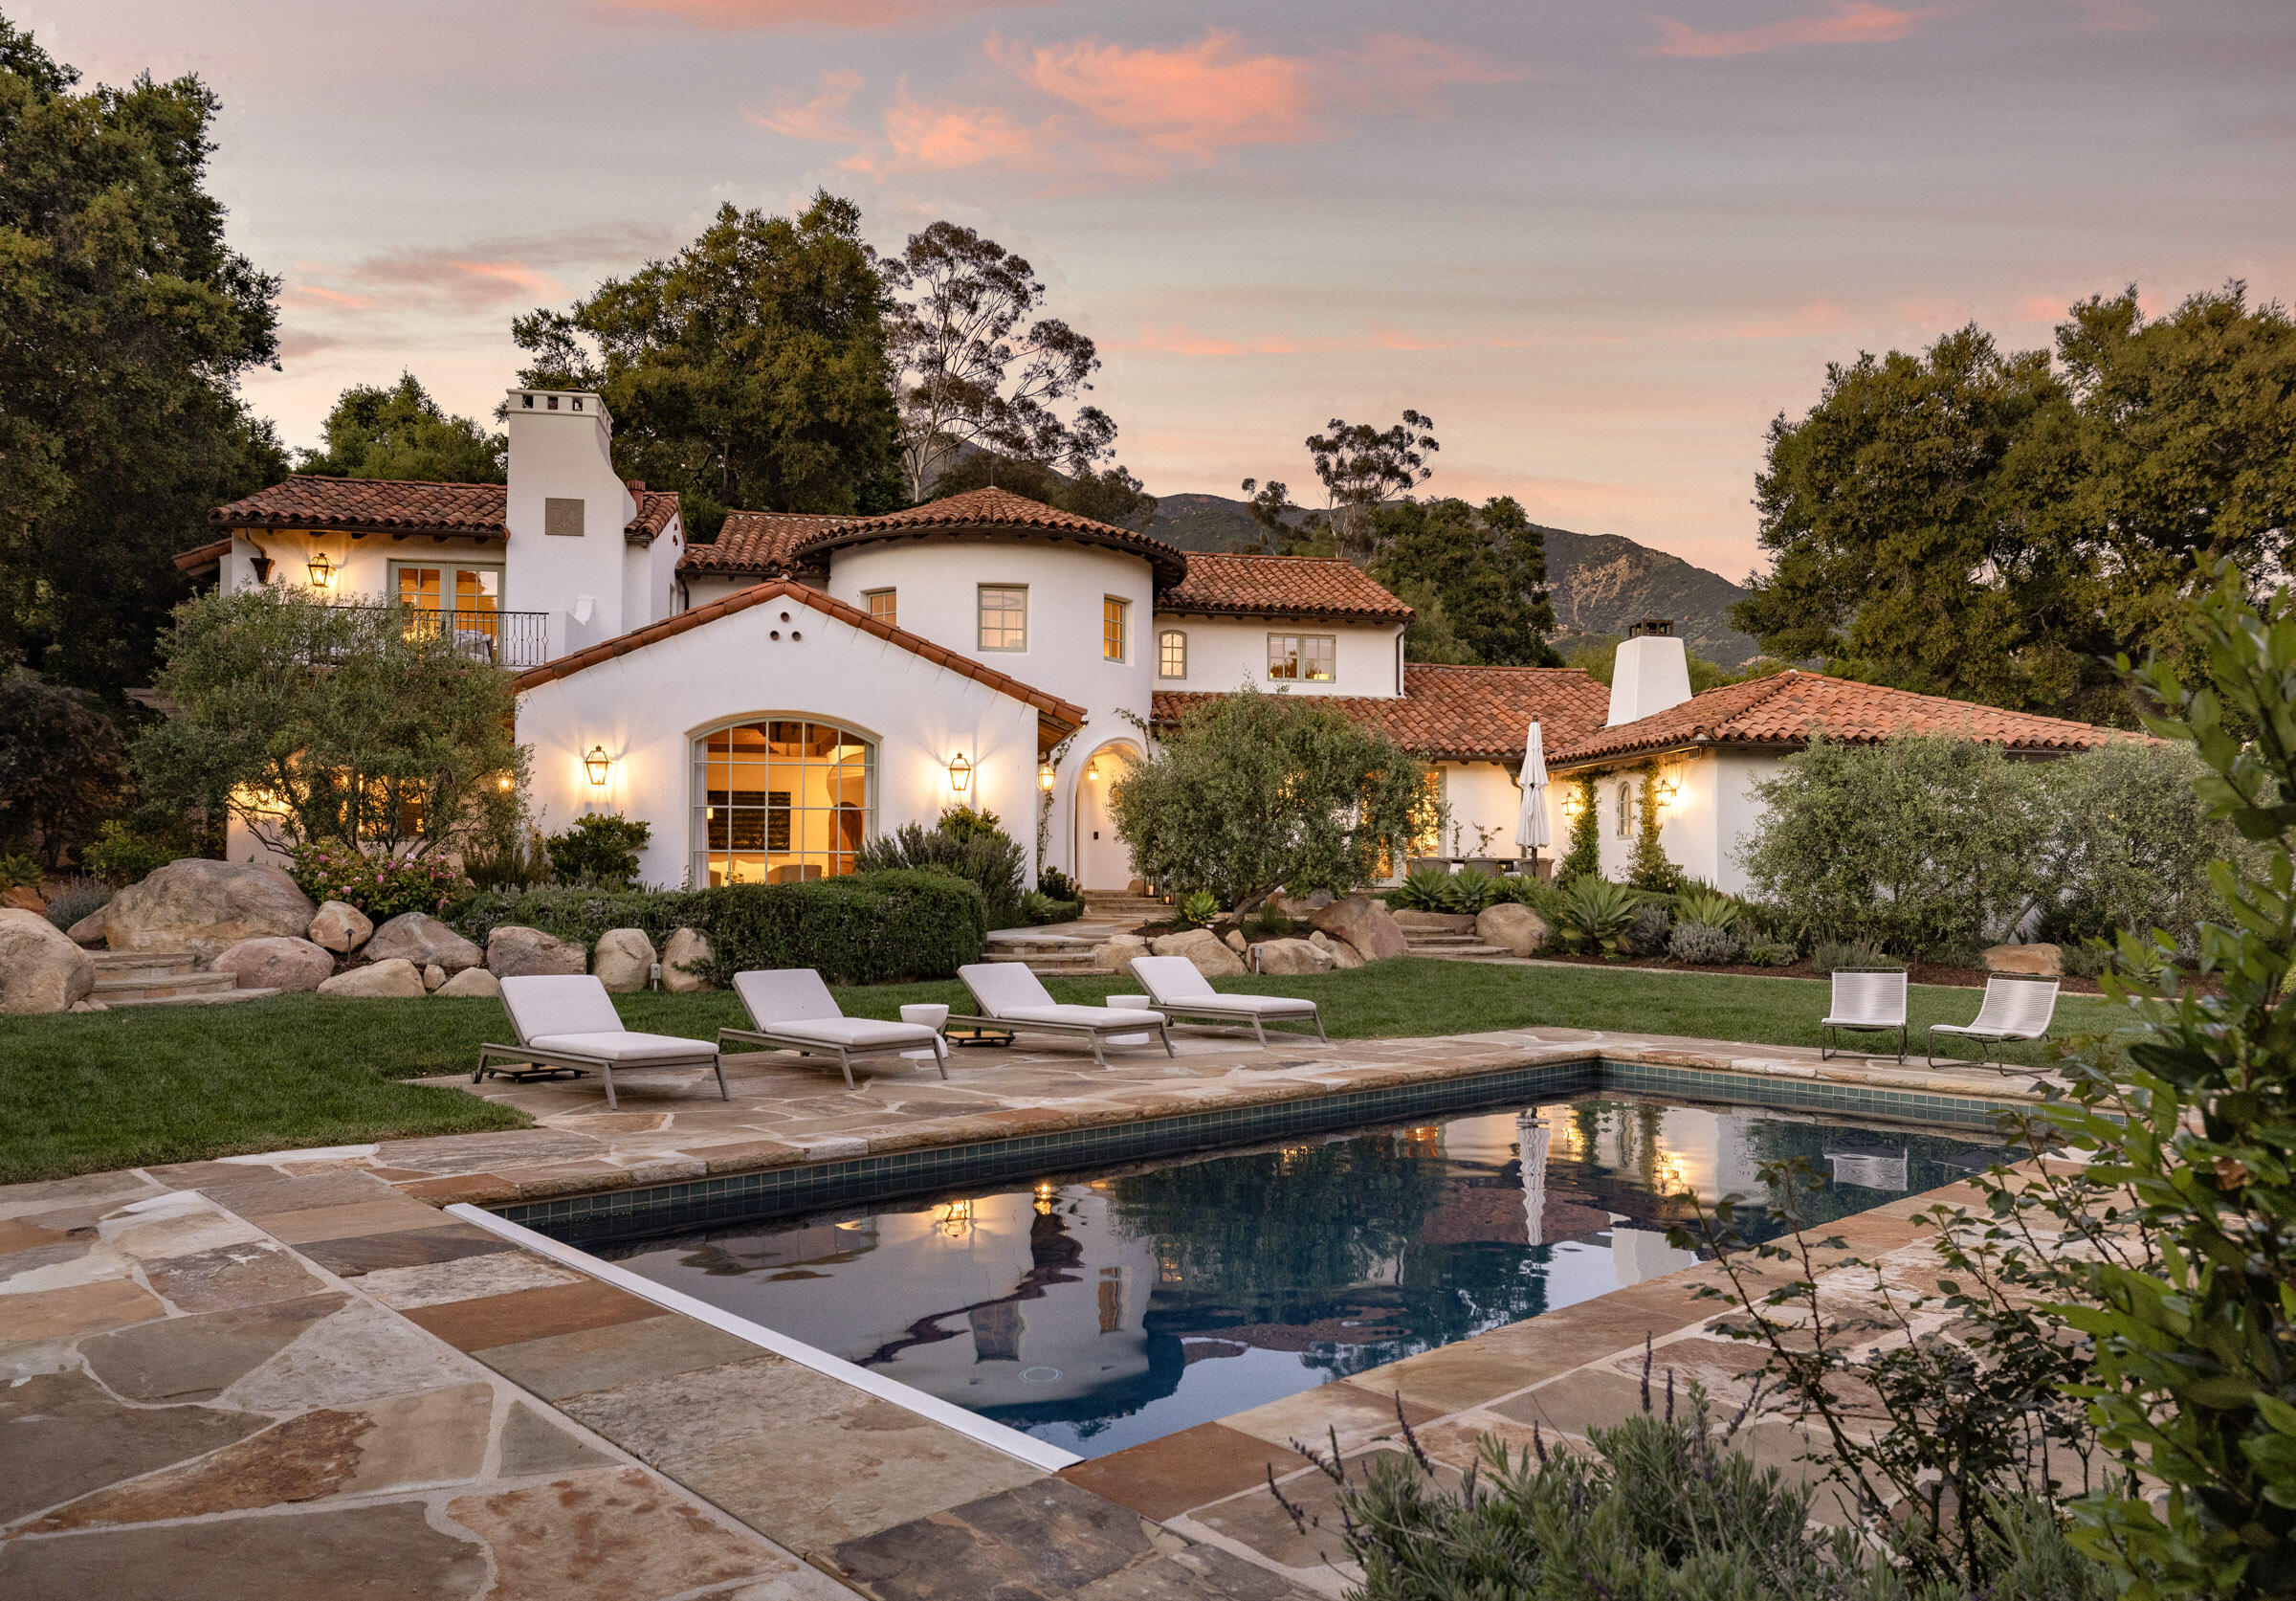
[691,717,877,884]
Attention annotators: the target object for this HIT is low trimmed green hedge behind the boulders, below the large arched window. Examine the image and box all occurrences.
[446,871,989,986]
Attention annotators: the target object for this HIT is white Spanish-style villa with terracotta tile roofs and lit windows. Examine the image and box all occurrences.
[177,389,2110,891]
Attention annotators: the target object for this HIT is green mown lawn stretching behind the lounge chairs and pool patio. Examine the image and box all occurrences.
[0,958,2117,1183]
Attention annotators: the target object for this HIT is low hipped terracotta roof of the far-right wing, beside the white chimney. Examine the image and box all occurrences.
[1548,668,2140,765]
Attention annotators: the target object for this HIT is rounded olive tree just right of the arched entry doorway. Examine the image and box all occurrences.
[1109,687,1442,912]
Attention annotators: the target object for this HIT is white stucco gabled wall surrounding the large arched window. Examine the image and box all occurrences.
[519,592,1038,887]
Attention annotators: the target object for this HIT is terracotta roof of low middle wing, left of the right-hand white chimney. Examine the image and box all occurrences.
[1150,661,1609,763]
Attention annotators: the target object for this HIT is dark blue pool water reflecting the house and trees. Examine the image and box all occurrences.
[602,1096,1999,1456]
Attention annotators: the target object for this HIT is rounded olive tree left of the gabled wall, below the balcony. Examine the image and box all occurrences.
[136,588,526,856]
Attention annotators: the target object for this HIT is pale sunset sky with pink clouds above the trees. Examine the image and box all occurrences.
[35,0,2296,576]
